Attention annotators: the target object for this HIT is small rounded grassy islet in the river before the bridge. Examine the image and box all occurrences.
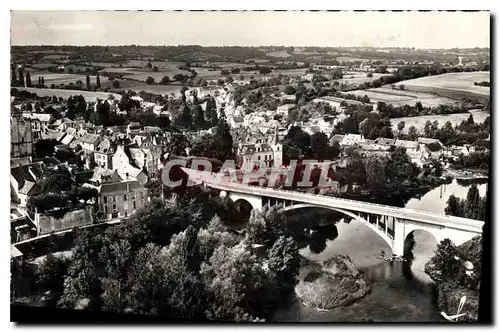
[295,255,370,310]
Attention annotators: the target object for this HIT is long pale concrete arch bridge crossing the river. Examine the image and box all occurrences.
[196,179,484,256]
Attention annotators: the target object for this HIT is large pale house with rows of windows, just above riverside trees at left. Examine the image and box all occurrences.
[97,180,148,220]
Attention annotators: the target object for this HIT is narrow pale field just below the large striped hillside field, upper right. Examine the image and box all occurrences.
[347,86,457,107]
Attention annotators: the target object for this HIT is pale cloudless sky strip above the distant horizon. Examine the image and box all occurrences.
[11,11,490,49]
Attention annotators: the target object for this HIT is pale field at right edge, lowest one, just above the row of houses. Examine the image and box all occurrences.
[391,110,490,134]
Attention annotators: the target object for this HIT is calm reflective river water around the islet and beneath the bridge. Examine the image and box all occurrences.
[273,181,487,322]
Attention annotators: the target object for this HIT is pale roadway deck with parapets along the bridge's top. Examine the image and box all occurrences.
[205,179,484,226]
